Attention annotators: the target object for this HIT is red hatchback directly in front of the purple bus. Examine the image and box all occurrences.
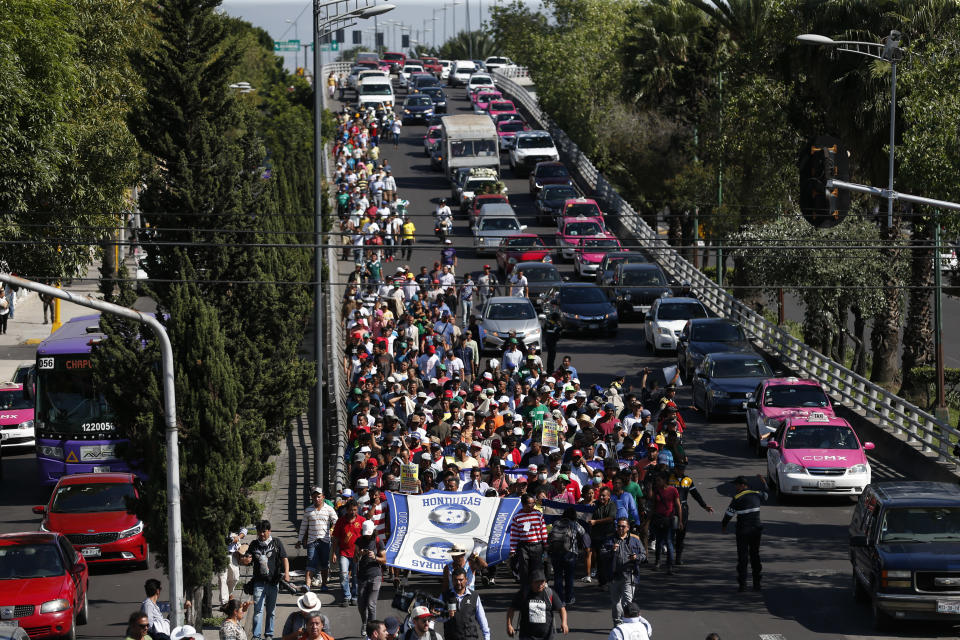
[33,473,148,569]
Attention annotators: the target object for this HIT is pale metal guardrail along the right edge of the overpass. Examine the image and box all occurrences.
[493,69,960,469]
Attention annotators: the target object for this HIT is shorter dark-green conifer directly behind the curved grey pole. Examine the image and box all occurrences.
[93,272,253,590]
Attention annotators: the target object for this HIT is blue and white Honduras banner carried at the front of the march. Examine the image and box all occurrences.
[387,491,520,575]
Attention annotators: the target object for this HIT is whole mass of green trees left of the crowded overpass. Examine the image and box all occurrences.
[0,0,313,586]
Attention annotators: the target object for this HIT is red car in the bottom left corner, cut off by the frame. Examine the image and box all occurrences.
[0,532,90,639]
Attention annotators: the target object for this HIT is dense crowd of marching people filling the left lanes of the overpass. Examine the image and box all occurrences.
[300,104,728,640]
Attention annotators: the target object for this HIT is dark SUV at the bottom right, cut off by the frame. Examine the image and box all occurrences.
[849,481,960,628]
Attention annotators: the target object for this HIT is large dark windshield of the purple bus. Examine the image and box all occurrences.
[36,354,115,435]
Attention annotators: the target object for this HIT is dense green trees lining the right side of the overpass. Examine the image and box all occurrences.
[490,0,960,400]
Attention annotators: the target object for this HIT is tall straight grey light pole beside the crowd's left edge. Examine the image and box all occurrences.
[313,0,395,487]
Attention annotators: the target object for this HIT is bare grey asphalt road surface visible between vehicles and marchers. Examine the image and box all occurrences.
[0,77,955,640]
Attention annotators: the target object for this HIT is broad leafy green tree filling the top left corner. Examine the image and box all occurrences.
[0,0,143,280]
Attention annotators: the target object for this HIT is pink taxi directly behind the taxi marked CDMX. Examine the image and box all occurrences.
[744,378,833,456]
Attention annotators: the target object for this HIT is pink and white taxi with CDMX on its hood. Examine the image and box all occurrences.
[767,412,873,500]
